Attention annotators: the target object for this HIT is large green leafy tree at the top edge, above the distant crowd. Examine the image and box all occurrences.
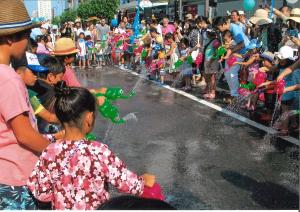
[77,0,120,19]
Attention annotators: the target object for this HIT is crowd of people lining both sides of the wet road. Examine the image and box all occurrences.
[0,0,300,209]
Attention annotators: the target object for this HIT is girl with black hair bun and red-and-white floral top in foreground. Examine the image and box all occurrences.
[28,81,155,210]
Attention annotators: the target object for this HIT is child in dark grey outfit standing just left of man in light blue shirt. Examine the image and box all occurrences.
[204,29,219,99]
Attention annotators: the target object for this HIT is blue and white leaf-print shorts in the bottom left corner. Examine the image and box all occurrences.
[0,184,37,210]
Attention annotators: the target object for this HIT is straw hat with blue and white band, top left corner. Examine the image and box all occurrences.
[0,0,41,36]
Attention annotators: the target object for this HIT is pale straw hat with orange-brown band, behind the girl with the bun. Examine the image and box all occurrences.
[54,38,79,56]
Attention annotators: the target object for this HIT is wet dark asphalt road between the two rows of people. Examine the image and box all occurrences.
[77,68,299,209]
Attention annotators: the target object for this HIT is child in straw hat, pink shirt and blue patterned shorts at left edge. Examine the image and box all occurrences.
[0,0,50,210]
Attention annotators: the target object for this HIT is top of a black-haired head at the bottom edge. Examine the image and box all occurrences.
[98,195,176,210]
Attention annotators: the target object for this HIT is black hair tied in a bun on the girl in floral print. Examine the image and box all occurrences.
[54,81,97,129]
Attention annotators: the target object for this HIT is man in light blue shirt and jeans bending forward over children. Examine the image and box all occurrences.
[213,16,250,103]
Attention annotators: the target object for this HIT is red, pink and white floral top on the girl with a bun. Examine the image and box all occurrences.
[27,139,144,210]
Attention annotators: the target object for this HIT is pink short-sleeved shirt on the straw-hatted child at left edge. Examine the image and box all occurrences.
[0,64,38,186]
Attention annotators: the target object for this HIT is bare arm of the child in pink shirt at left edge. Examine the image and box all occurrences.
[8,113,50,152]
